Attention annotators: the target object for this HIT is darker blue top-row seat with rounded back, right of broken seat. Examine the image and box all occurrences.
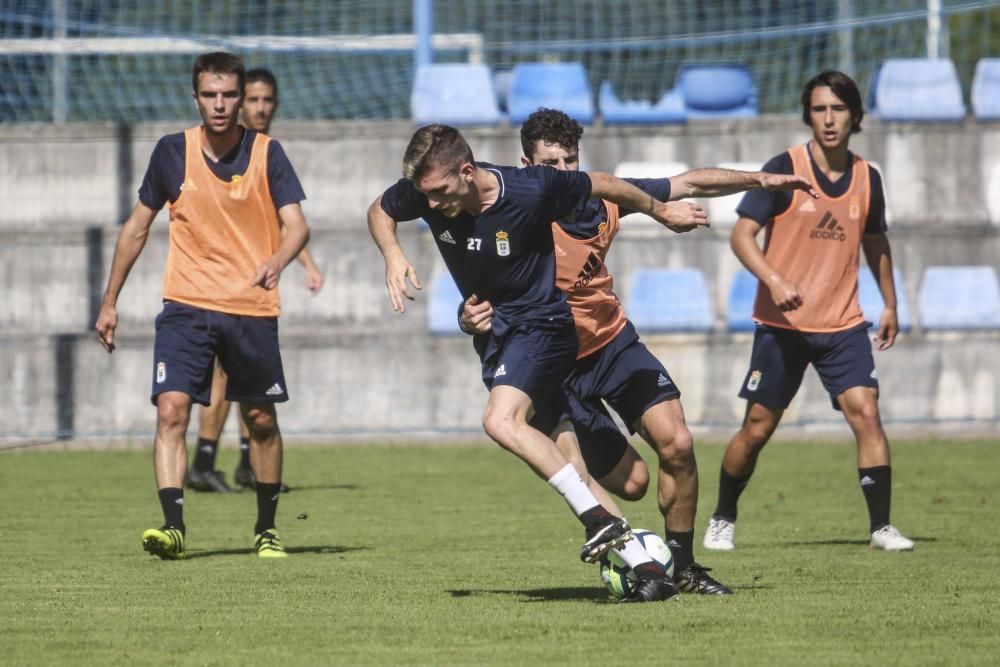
[677,64,757,119]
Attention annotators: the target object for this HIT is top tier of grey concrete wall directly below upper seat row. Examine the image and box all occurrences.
[0,117,1000,228]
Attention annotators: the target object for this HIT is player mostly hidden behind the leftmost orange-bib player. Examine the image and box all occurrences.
[185,68,323,493]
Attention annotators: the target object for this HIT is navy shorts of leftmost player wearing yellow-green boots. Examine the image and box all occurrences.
[151,301,288,405]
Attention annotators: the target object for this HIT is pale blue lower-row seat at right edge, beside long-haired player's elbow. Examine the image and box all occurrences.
[920,266,1000,330]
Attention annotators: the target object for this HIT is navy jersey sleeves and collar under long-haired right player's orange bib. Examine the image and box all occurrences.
[736,151,888,234]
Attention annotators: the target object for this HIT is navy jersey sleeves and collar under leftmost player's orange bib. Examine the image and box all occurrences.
[139,128,306,211]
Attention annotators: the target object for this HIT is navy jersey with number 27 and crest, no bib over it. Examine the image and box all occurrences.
[382,163,591,336]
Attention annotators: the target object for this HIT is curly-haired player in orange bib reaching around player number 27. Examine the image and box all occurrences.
[461,109,810,595]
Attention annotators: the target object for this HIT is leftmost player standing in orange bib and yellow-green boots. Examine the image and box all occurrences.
[95,52,309,560]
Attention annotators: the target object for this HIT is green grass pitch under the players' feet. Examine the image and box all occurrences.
[0,439,1000,666]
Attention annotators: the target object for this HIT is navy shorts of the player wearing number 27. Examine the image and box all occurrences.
[477,321,579,428]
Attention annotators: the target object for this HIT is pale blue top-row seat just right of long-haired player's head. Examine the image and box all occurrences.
[875,58,965,121]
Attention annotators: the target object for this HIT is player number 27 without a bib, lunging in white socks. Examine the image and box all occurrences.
[368,125,707,602]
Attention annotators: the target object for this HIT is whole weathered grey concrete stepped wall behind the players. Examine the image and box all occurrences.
[0,118,1000,438]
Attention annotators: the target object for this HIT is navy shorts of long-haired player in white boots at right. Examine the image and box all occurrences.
[740,322,878,410]
